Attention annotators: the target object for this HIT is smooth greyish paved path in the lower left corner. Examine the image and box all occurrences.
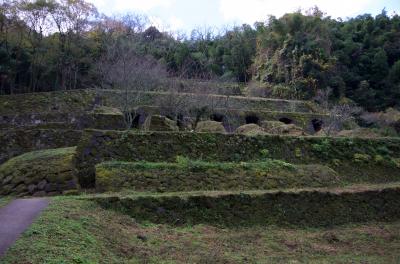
[0,198,49,257]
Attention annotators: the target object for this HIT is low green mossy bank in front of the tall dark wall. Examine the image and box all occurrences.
[96,157,340,192]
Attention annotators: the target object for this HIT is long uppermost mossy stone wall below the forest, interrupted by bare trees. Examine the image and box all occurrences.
[0,89,318,115]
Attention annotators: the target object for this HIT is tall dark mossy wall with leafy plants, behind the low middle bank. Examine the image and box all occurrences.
[76,130,400,187]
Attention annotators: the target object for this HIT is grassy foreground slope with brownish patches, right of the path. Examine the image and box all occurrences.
[1,198,400,263]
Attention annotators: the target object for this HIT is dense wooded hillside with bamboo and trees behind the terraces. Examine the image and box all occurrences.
[0,0,400,111]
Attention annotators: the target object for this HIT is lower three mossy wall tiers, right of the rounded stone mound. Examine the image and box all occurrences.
[72,130,400,226]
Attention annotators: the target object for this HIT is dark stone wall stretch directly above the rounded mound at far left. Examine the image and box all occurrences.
[0,129,82,164]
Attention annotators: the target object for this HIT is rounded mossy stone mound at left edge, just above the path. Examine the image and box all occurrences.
[0,147,79,196]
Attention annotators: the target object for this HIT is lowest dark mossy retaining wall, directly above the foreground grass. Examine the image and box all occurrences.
[92,184,400,227]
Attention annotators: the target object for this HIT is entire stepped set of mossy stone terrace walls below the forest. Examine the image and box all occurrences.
[0,90,400,229]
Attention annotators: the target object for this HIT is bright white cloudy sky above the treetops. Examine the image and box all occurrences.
[89,0,400,33]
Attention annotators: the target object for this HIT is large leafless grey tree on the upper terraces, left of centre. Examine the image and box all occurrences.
[97,17,167,129]
